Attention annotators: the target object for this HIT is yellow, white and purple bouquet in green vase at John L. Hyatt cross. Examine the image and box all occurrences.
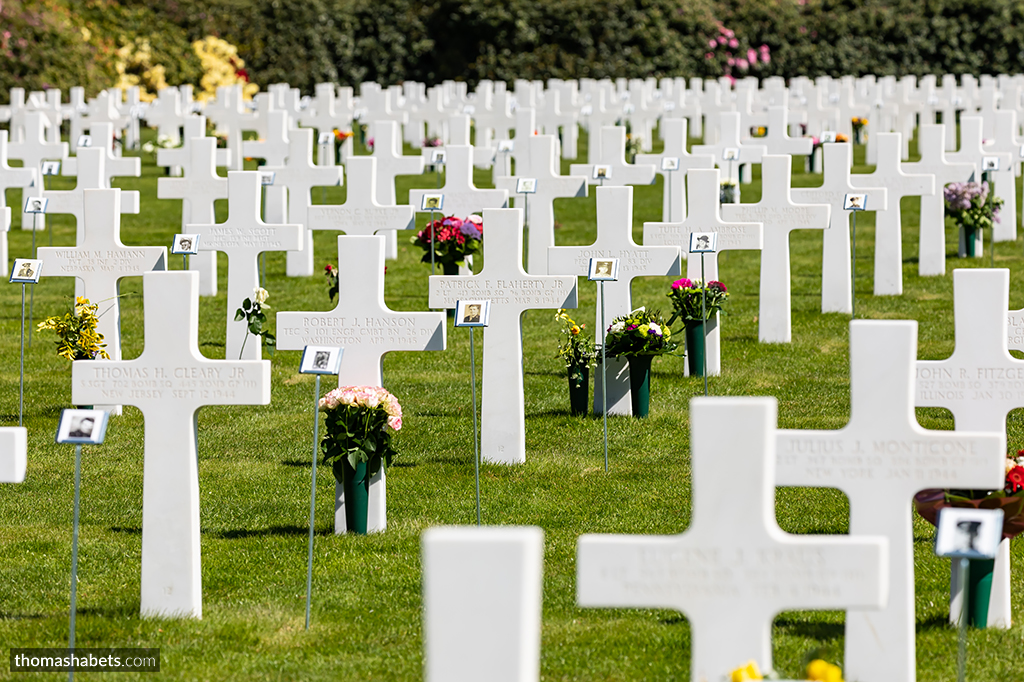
[604,307,679,417]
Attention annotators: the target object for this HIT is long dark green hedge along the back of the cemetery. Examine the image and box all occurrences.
[6,0,1024,99]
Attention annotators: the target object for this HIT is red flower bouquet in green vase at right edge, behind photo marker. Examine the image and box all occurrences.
[913,450,1024,628]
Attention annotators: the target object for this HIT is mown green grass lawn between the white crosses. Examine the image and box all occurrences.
[0,124,1024,682]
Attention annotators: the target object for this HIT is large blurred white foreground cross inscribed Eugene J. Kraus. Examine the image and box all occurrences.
[577,397,892,682]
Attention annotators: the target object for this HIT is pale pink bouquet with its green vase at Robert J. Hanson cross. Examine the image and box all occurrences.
[319,386,401,534]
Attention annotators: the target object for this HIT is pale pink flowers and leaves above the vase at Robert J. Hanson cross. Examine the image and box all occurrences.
[319,386,401,482]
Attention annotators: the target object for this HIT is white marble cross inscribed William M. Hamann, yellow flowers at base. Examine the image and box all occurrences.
[39,186,167,374]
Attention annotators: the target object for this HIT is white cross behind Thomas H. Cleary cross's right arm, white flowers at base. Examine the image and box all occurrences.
[185,171,305,359]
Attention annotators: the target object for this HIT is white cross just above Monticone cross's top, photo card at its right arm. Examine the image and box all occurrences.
[793,142,888,312]
